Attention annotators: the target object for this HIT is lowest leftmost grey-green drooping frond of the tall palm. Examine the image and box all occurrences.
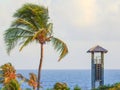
[4,28,33,54]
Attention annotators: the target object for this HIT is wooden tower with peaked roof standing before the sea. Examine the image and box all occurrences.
[87,45,108,89]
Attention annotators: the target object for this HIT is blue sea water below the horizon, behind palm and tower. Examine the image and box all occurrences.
[17,70,120,90]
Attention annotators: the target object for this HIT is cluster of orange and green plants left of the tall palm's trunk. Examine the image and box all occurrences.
[0,63,37,90]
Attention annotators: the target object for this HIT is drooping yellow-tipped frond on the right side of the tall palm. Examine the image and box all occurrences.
[51,37,68,61]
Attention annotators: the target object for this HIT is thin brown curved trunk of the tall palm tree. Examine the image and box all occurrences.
[37,44,43,90]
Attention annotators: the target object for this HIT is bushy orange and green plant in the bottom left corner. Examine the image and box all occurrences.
[0,63,21,90]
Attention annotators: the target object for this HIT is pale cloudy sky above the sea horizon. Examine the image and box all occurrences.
[0,0,120,69]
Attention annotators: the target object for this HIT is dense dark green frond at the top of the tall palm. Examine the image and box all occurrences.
[14,3,49,30]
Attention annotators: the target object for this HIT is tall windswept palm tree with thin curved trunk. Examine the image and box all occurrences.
[4,4,68,90]
